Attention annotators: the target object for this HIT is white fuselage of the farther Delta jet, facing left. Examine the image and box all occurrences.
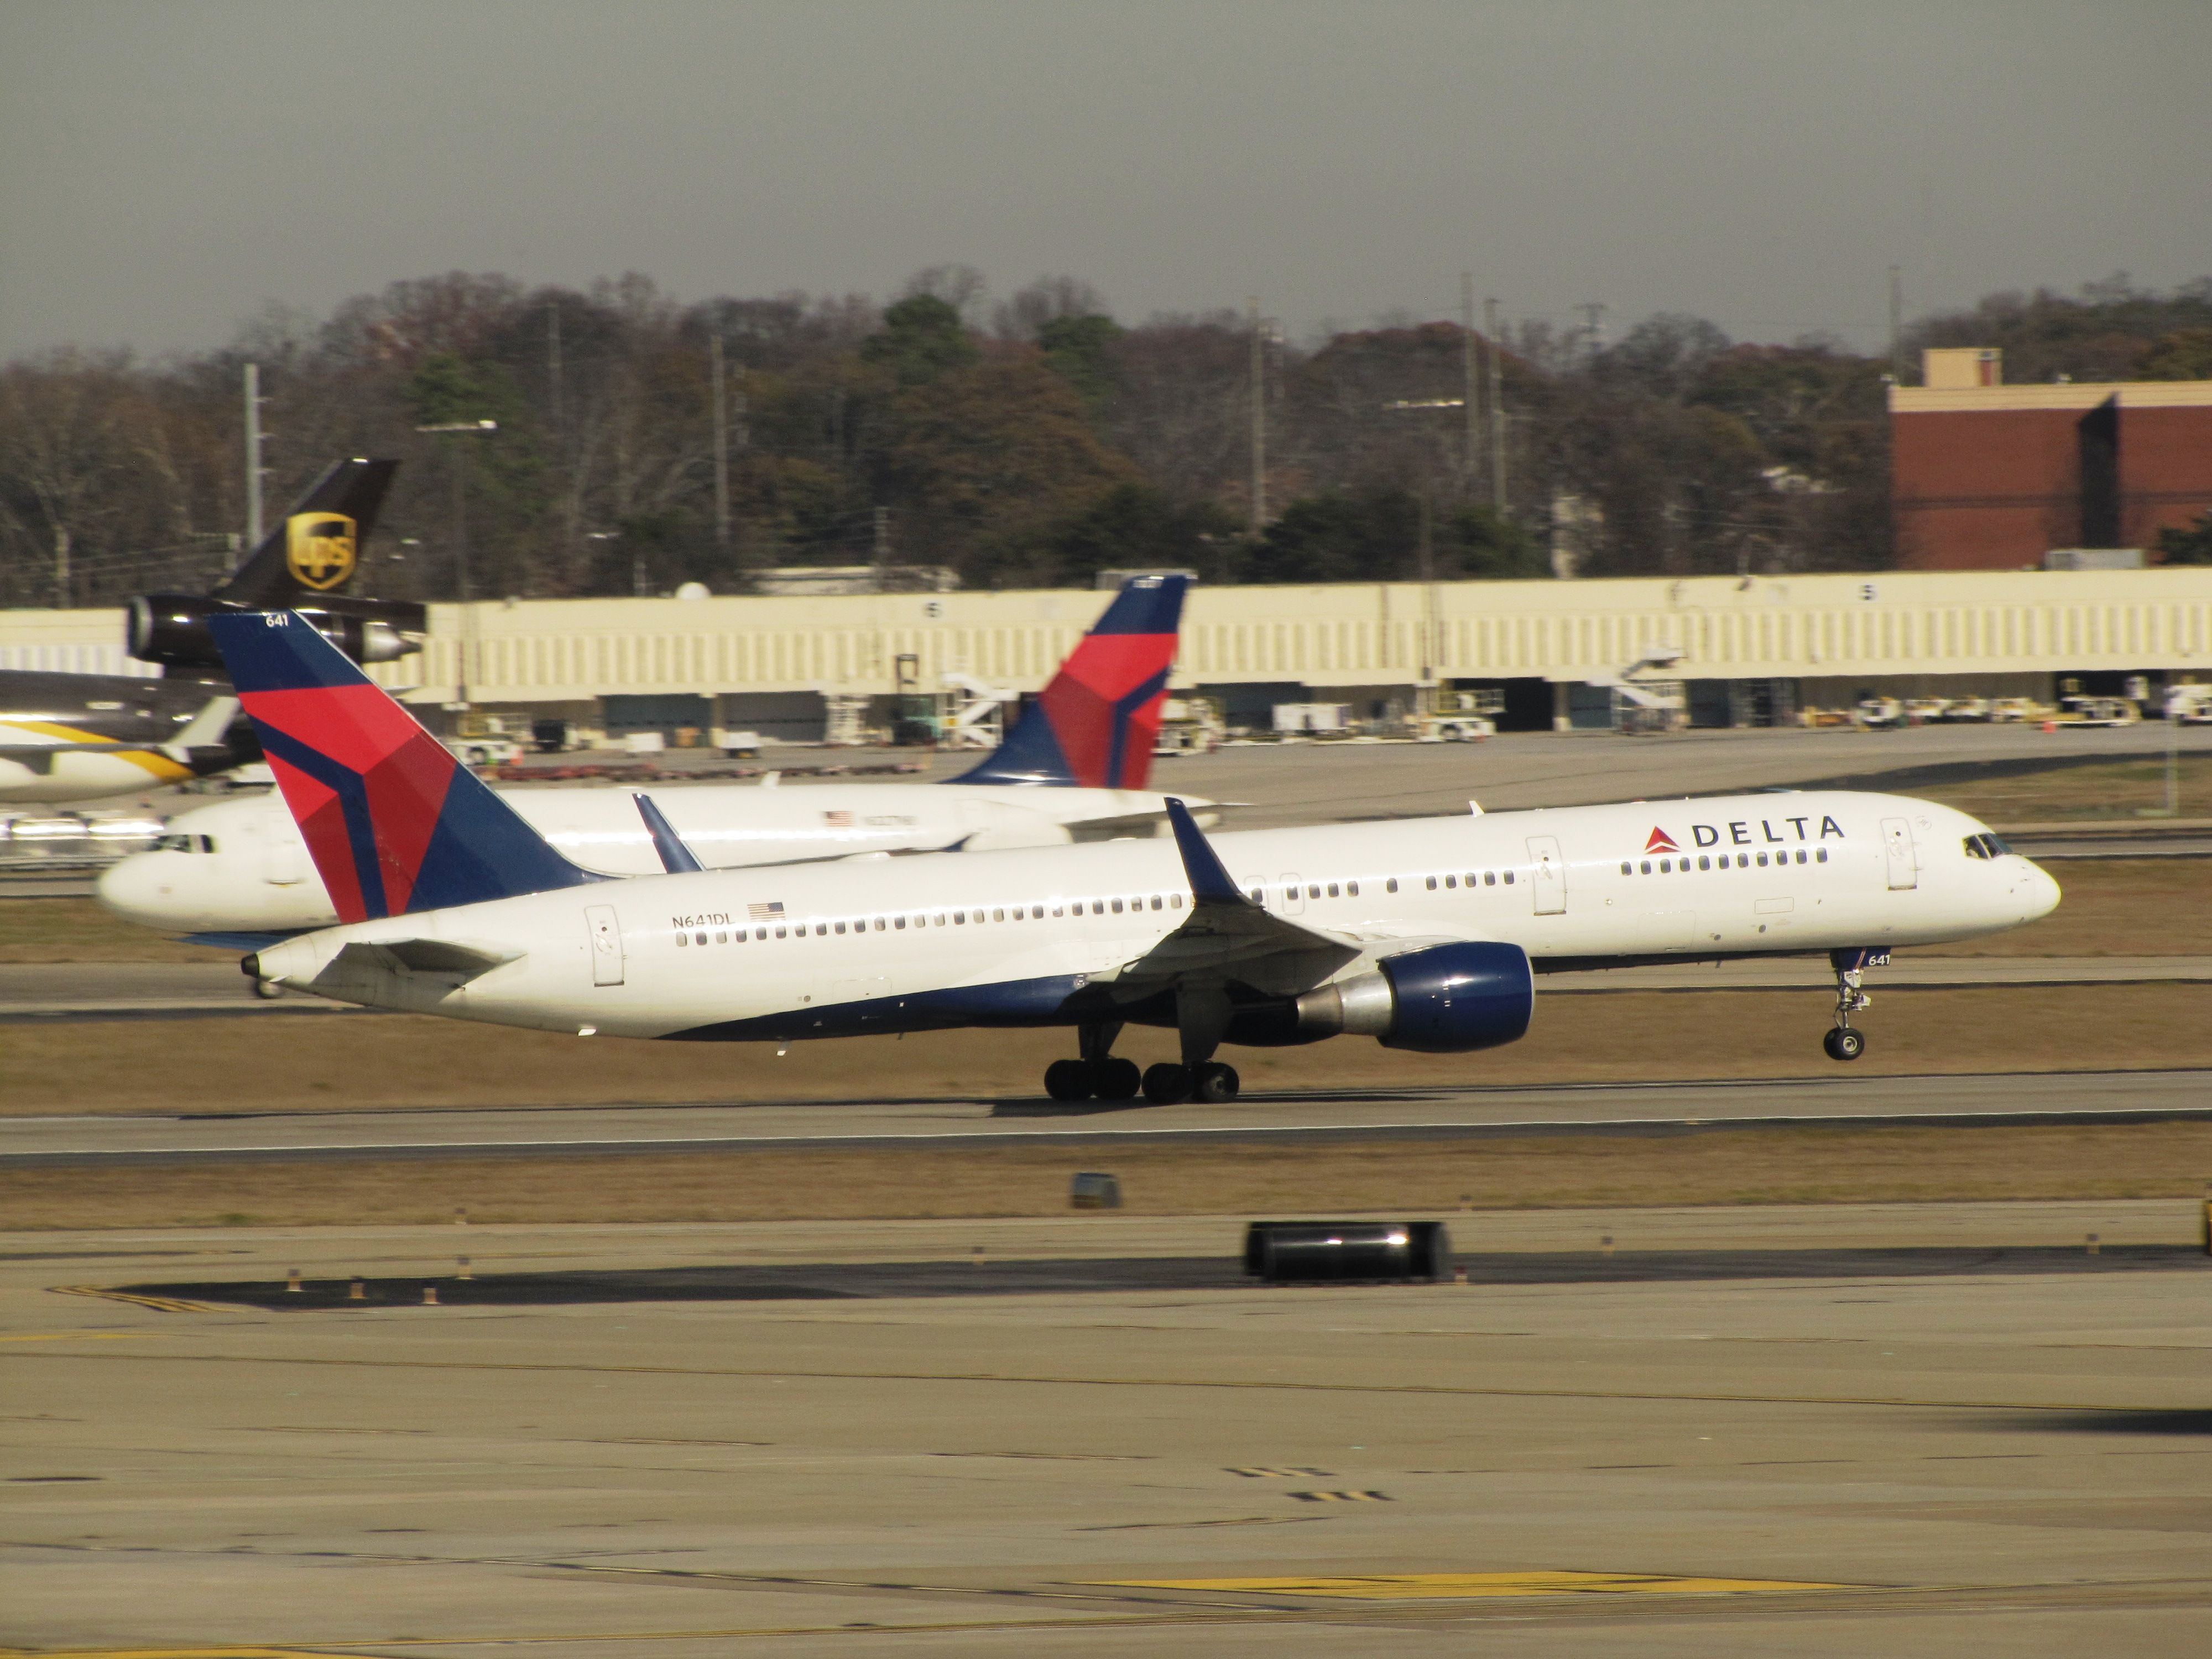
[100,783,1206,933]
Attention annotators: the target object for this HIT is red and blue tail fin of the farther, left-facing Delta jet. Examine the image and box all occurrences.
[949,575,1190,790]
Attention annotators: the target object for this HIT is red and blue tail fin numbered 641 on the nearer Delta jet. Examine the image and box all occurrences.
[208,611,597,922]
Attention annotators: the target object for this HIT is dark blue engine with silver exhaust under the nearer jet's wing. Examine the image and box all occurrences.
[1298,945,1535,1055]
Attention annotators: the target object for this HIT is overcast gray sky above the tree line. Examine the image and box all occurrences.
[0,0,2212,356]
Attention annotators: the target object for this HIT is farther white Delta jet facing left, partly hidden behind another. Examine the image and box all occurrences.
[100,575,1210,933]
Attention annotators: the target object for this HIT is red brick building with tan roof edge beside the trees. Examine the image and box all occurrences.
[1889,349,2212,571]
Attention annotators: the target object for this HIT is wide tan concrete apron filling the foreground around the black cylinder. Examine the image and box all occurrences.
[0,1201,2212,1659]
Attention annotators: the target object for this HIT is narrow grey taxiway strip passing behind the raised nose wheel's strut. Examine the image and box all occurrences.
[0,956,2212,1024]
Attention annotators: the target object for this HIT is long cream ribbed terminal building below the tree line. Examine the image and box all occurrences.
[0,566,2212,741]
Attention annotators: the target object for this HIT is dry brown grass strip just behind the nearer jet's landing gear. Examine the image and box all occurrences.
[0,973,2212,1117]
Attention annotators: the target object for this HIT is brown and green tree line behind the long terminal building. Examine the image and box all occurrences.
[0,265,2212,606]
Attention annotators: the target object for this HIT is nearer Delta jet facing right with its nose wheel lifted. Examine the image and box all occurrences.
[212,613,2059,1104]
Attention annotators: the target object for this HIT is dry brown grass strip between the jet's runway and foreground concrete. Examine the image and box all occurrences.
[0,1124,2212,1230]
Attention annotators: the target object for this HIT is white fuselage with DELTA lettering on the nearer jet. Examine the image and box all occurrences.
[259,792,2057,1040]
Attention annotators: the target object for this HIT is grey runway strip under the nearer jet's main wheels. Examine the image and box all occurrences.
[0,1071,2212,1168]
